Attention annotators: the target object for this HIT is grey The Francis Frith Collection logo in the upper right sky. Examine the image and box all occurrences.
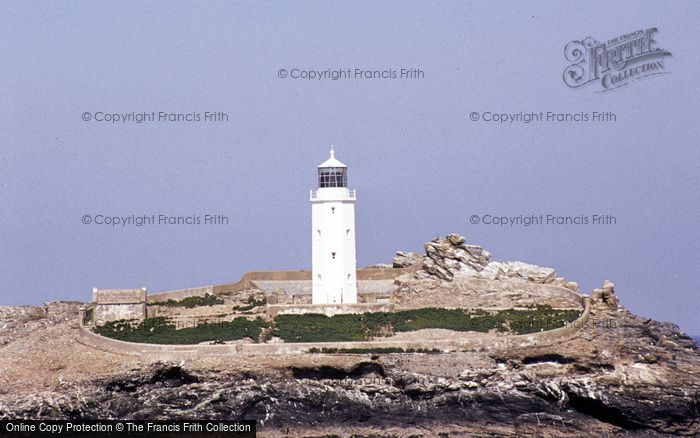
[564,27,671,92]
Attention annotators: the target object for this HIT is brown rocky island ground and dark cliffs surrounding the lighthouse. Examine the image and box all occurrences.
[0,235,700,437]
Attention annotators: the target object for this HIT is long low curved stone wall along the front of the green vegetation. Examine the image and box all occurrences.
[79,297,591,361]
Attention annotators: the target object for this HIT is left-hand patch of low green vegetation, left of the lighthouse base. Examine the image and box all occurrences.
[95,316,268,344]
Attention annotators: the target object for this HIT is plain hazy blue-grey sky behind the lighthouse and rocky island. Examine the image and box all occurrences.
[0,1,700,334]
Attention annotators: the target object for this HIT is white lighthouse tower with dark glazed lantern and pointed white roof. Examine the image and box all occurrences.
[310,146,357,304]
